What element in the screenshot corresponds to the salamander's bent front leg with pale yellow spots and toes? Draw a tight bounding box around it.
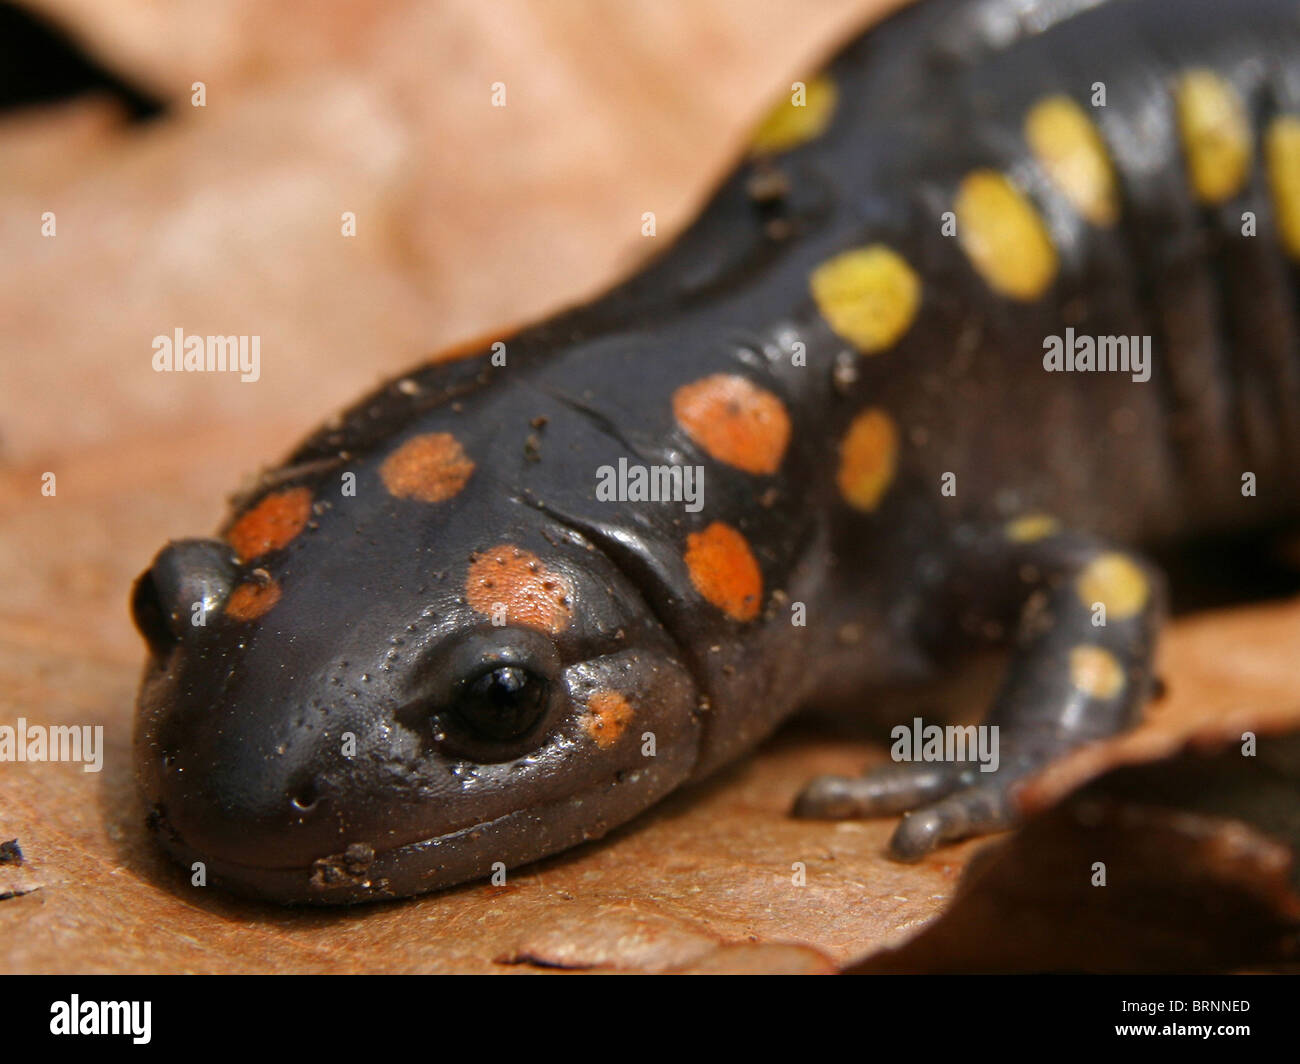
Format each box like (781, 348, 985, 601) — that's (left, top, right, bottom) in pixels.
(794, 518, 1165, 861)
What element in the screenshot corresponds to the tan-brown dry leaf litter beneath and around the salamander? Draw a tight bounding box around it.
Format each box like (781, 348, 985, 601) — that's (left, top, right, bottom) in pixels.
(0, 0, 1300, 972)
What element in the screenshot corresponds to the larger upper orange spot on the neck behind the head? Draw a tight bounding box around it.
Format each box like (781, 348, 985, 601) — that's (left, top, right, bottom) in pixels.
(672, 373, 790, 473)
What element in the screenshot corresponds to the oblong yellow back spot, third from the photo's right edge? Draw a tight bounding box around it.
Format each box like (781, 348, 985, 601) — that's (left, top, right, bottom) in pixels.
(1024, 96, 1119, 225)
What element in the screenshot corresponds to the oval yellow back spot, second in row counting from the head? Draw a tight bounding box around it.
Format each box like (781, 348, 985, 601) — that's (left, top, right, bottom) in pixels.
(953, 170, 1057, 302)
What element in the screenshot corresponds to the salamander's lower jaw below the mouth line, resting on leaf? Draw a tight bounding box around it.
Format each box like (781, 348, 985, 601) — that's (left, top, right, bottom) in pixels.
(148, 762, 681, 905)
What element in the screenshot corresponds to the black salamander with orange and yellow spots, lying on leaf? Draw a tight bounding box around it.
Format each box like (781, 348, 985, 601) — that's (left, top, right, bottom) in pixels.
(131, 0, 1300, 903)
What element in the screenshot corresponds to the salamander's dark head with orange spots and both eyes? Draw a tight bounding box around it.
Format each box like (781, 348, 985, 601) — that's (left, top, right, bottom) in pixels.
(133, 434, 699, 903)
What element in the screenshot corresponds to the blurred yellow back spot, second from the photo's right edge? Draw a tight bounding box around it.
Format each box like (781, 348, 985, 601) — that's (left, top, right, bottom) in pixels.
(1175, 70, 1253, 203)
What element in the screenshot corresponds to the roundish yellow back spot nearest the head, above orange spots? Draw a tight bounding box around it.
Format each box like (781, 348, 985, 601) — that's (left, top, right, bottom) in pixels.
(809, 243, 920, 355)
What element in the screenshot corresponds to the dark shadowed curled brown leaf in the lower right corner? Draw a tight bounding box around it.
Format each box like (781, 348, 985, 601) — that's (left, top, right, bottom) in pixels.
(855, 731, 1300, 972)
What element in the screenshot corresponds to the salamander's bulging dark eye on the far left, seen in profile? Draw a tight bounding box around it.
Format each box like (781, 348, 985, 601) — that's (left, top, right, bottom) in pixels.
(131, 540, 238, 658)
